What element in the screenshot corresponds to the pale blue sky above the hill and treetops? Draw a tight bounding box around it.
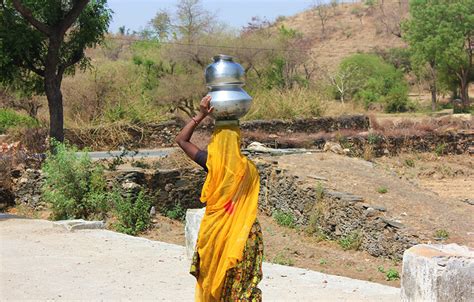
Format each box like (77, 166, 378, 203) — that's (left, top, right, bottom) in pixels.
(108, 0, 313, 32)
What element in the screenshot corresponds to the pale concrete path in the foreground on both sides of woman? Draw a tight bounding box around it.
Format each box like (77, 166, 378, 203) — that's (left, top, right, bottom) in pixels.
(0, 217, 400, 301)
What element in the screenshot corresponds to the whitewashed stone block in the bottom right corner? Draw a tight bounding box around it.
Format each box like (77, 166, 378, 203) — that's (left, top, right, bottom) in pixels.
(401, 244, 474, 302)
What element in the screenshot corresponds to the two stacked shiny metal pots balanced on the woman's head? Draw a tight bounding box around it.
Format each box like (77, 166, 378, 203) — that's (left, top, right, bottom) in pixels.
(205, 55, 252, 121)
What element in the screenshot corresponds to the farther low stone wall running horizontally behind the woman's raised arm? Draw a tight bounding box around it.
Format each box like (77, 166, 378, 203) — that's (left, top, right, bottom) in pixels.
(9, 115, 474, 156)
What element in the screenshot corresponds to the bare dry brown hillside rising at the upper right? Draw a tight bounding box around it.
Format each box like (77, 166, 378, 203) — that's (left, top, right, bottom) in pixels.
(277, 1, 407, 68)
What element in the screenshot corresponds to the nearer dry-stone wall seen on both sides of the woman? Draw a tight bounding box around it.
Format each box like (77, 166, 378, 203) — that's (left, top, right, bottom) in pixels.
(9, 160, 417, 258)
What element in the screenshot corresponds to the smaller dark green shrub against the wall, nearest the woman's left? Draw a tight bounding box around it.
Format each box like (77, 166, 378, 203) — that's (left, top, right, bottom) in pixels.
(111, 189, 151, 235)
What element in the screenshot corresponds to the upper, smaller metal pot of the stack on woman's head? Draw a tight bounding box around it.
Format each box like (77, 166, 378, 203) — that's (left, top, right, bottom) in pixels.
(206, 55, 244, 87)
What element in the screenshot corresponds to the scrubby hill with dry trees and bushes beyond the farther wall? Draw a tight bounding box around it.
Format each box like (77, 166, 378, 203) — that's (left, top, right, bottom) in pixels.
(0, 0, 474, 138)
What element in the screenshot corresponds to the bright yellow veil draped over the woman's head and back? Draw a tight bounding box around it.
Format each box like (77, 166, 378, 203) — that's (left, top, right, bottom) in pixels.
(196, 126, 260, 302)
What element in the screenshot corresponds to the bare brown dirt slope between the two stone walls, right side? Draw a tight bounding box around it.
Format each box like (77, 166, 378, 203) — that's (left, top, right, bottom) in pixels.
(272, 153, 474, 247)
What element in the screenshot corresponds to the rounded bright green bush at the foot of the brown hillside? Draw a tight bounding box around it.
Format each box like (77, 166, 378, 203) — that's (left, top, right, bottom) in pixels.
(339, 54, 410, 112)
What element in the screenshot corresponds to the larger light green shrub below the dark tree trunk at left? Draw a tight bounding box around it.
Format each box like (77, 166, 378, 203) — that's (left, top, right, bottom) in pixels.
(42, 141, 109, 220)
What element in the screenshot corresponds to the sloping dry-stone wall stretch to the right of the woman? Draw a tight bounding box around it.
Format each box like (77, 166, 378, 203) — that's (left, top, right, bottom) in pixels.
(258, 162, 417, 259)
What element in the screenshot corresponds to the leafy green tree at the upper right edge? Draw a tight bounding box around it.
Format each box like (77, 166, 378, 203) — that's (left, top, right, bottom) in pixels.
(403, 0, 474, 110)
